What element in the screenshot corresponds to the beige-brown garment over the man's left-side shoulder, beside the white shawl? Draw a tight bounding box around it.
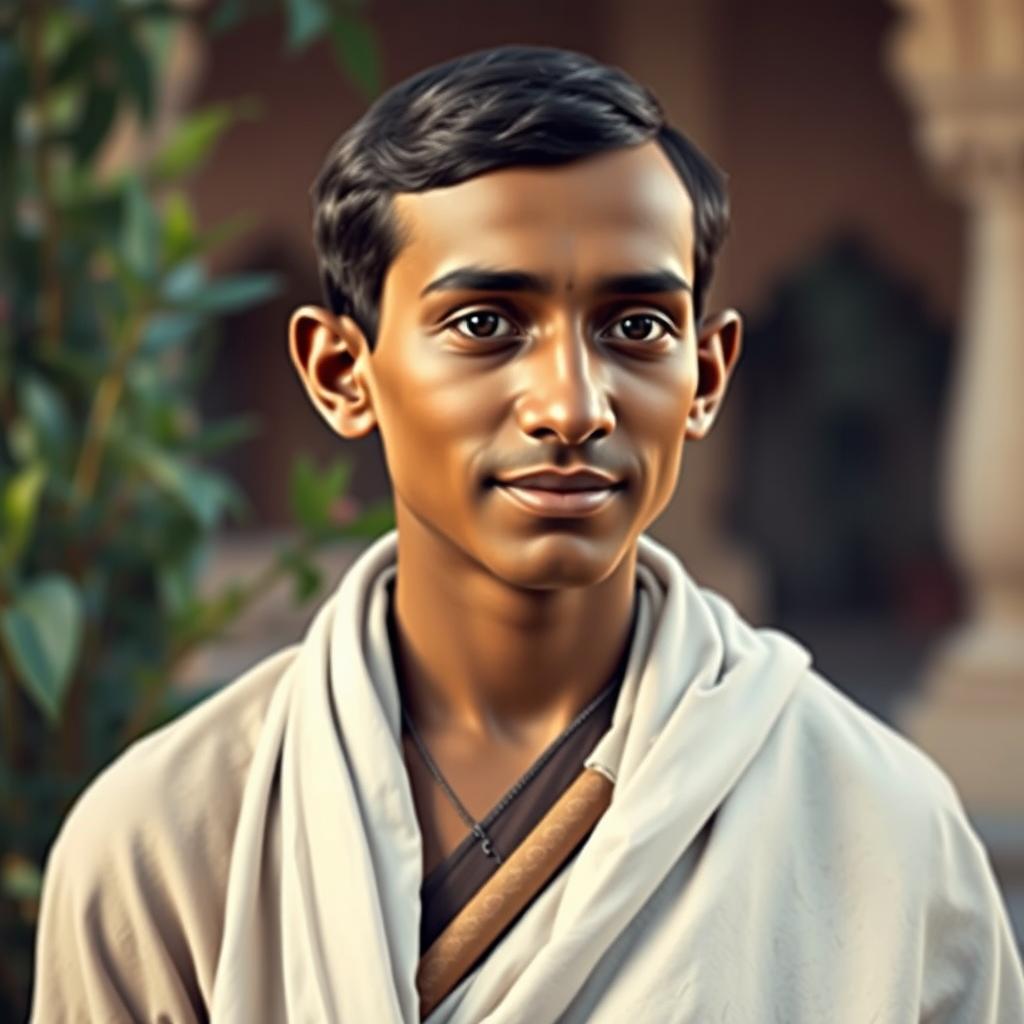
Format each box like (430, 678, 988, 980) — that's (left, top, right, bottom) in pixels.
(34, 648, 295, 1020)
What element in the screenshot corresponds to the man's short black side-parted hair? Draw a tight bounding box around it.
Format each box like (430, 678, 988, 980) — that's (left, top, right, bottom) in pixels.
(310, 46, 729, 346)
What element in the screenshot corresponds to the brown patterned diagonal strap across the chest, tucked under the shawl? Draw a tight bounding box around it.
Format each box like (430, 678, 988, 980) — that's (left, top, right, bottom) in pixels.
(416, 768, 613, 1020)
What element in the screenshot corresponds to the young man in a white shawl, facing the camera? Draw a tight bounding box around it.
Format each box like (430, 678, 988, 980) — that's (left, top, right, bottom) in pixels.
(28, 48, 1024, 1024)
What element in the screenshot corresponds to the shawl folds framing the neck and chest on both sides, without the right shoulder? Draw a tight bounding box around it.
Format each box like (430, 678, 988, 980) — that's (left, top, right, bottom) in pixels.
(213, 534, 823, 1022)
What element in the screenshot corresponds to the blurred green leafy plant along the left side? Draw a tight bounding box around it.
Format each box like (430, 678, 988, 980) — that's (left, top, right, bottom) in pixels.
(0, 0, 392, 1019)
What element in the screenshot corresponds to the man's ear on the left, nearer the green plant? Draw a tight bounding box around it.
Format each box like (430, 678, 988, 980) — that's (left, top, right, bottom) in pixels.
(288, 306, 377, 438)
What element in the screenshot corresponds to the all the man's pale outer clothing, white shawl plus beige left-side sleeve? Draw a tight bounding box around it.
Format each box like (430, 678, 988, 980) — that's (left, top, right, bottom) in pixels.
(33, 534, 1024, 1024)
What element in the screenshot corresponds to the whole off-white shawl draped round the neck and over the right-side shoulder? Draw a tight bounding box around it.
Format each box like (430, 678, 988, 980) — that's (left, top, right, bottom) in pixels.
(207, 535, 1024, 1024)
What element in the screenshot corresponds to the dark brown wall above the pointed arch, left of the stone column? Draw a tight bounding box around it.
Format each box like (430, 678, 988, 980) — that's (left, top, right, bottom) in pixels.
(717, 0, 962, 315)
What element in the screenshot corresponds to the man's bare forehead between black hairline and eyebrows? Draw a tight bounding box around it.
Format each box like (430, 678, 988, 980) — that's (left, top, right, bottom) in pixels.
(385, 142, 693, 298)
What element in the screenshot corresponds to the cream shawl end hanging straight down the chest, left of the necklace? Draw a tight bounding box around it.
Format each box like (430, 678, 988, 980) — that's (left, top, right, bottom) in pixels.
(212, 535, 422, 1024)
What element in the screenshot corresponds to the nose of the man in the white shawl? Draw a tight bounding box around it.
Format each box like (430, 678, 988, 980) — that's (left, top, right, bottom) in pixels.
(518, 328, 615, 444)
